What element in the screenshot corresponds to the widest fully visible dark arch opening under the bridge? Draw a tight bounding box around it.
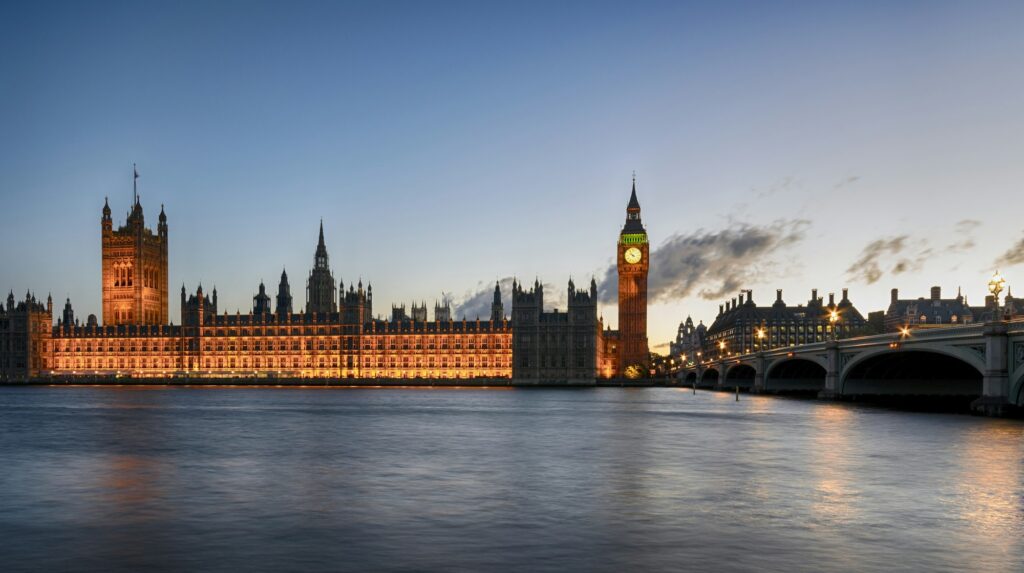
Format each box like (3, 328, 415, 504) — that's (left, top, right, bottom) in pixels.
(841, 349, 983, 398)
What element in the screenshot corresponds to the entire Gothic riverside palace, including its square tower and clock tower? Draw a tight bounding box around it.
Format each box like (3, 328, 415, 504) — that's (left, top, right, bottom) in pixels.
(0, 177, 648, 384)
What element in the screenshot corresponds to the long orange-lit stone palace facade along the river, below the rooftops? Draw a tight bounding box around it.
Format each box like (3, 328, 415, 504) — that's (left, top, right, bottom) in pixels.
(53, 287, 512, 379)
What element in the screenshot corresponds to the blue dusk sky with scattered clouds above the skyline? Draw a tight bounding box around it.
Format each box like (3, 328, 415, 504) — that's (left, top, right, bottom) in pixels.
(0, 1, 1024, 350)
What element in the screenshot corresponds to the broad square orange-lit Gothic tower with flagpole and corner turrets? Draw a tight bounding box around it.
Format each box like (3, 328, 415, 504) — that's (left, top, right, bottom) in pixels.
(100, 167, 169, 325)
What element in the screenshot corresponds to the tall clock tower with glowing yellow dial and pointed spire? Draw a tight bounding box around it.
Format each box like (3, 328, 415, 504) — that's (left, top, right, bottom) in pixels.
(615, 177, 650, 378)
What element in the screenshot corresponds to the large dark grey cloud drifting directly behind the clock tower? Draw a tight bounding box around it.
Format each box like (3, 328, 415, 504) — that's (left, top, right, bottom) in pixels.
(600, 219, 811, 304)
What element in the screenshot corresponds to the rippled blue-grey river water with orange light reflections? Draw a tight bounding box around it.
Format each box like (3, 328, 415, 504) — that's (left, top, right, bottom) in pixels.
(0, 387, 1024, 573)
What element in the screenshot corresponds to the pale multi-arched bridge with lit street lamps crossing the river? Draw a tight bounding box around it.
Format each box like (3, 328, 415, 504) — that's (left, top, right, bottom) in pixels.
(676, 319, 1024, 415)
